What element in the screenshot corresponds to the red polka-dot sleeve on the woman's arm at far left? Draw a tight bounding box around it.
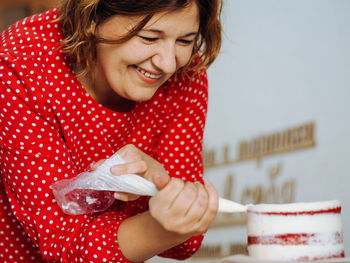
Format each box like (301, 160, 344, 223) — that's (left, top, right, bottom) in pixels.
(0, 55, 129, 262)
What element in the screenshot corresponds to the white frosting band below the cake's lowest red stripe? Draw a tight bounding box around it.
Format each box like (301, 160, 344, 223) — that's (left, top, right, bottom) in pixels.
(248, 244, 344, 260)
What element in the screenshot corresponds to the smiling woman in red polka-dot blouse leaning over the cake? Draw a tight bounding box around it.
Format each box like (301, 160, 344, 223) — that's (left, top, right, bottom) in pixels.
(0, 0, 221, 262)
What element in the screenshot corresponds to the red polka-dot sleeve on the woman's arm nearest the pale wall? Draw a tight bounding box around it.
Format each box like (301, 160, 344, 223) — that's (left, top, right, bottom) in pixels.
(156, 70, 208, 259)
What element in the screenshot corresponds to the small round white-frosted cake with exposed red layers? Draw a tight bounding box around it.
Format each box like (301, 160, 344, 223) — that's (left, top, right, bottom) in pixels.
(247, 200, 344, 261)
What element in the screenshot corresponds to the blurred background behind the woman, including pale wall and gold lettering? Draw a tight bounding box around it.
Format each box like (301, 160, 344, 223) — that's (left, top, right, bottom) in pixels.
(0, 0, 350, 262)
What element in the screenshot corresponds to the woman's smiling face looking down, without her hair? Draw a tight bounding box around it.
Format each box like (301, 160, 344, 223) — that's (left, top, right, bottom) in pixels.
(93, 3, 199, 101)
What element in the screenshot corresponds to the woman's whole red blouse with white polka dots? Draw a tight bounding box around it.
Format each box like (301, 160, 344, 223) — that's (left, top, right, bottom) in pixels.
(0, 9, 208, 262)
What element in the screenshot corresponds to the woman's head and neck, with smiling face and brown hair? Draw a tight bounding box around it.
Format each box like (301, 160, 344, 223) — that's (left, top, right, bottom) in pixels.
(61, 1, 221, 111)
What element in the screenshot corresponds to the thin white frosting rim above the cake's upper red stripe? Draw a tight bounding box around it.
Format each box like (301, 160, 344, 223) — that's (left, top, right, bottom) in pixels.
(248, 200, 340, 213)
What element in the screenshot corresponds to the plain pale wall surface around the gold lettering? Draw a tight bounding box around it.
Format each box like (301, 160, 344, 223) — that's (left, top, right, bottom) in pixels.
(148, 0, 350, 262)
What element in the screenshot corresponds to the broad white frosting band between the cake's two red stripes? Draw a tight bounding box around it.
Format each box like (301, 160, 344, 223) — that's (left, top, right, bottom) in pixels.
(247, 213, 342, 236)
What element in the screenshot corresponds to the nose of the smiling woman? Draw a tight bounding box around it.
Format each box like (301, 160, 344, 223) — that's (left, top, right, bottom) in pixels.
(152, 42, 177, 74)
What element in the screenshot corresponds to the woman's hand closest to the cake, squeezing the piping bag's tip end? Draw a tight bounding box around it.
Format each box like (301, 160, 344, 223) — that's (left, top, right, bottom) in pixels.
(149, 178, 218, 237)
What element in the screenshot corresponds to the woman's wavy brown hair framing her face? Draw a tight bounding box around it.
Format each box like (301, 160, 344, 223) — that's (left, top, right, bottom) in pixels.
(58, 0, 222, 76)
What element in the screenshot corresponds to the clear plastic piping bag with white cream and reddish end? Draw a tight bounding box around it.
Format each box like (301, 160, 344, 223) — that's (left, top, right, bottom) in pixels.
(52, 154, 247, 215)
